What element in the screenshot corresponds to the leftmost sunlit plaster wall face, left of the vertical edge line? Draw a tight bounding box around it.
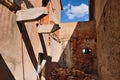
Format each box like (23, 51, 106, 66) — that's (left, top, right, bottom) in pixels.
(0, 4, 23, 80)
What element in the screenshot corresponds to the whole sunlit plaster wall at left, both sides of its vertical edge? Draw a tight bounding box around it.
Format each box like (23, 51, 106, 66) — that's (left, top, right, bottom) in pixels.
(0, 0, 43, 80)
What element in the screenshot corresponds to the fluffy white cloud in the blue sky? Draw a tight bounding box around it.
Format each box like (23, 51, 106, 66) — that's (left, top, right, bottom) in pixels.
(63, 3, 88, 19)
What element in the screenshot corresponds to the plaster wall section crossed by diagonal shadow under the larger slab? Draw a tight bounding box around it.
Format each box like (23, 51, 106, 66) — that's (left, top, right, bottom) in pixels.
(16, 0, 43, 80)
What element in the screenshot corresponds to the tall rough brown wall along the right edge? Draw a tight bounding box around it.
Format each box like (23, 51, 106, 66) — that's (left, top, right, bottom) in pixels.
(96, 0, 120, 80)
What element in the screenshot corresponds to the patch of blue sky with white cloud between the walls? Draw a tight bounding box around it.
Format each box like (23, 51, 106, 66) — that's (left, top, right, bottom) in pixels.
(61, 0, 89, 22)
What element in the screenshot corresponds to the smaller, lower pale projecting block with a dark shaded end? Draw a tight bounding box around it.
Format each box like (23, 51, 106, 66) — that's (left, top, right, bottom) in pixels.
(38, 24, 60, 33)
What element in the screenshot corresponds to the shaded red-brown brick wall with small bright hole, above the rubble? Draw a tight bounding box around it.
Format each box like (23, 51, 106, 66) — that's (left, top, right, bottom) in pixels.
(71, 21, 97, 74)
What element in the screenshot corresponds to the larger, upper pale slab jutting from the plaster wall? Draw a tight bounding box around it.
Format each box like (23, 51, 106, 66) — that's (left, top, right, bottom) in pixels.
(16, 7, 48, 21)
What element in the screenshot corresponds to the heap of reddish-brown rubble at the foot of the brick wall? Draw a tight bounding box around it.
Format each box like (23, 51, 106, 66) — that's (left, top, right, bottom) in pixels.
(49, 68, 98, 80)
